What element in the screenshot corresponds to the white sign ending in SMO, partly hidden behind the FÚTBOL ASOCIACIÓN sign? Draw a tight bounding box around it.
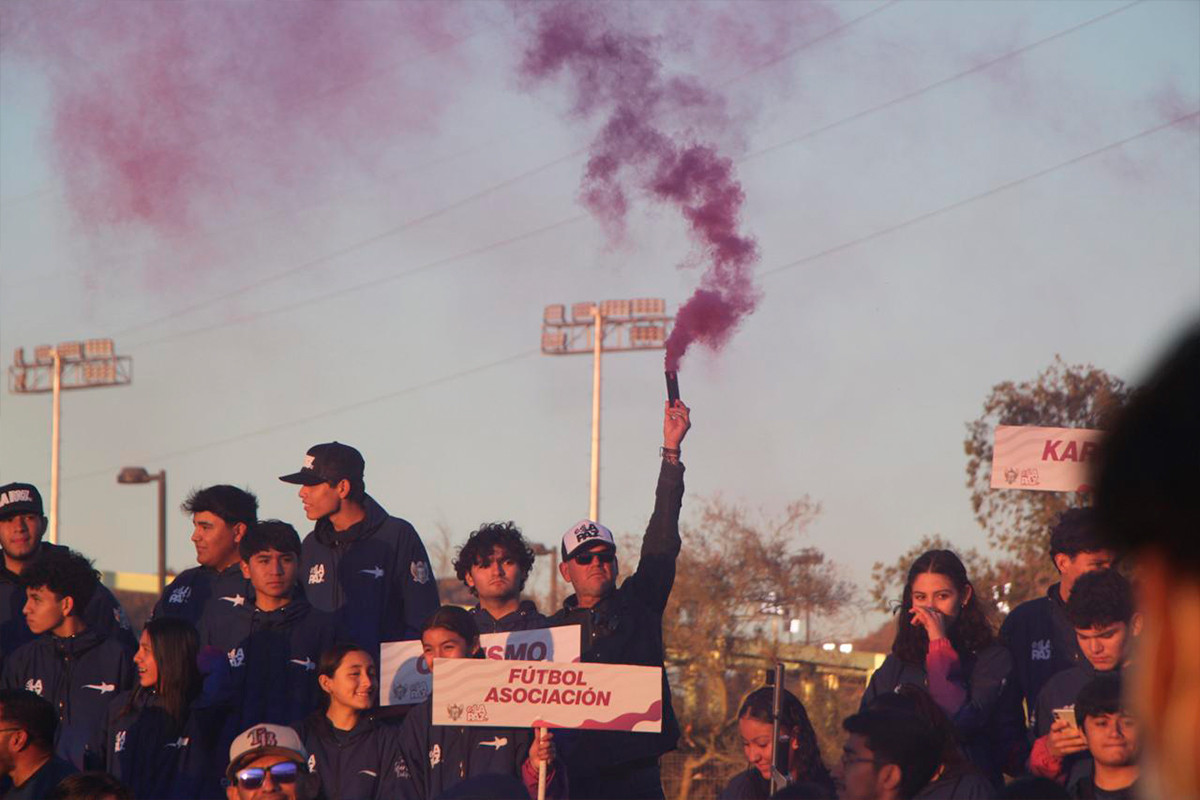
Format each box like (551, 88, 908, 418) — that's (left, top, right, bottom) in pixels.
(379, 625, 582, 705)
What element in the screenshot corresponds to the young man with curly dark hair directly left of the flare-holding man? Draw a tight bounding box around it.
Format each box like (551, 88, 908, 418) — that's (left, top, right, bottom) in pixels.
(454, 522, 546, 633)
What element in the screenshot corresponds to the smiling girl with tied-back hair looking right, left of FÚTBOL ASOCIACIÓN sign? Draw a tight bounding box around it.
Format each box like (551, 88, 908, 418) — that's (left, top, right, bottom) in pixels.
(294, 644, 408, 800)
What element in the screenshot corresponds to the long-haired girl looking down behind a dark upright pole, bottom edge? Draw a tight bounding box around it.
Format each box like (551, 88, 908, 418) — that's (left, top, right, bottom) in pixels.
(718, 686, 834, 800)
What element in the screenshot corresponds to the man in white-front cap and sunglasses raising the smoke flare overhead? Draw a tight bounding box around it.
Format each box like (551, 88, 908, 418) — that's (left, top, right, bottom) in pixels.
(548, 401, 691, 800)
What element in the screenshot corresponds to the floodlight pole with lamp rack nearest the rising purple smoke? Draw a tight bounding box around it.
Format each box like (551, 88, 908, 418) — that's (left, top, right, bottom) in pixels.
(541, 297, 674, 522)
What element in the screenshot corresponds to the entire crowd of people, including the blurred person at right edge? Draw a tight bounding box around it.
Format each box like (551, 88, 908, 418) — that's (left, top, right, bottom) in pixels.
(0, 323, 1200, 800)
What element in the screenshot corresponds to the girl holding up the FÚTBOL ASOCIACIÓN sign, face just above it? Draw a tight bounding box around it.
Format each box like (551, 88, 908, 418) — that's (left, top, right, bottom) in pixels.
(401, 606, 566, 800)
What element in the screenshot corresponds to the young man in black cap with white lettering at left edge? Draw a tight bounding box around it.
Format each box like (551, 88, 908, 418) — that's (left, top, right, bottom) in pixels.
(0, 483, 137, 662)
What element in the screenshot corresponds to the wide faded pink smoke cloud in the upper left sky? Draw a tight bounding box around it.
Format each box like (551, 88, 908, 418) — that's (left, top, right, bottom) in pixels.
(0, 0, 463, 234)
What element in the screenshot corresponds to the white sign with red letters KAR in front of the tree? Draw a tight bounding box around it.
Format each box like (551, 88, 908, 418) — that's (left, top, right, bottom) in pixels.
(991, 425, 1104, 492)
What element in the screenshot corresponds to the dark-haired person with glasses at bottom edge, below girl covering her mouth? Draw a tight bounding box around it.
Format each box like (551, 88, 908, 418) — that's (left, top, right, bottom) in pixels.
(833, 710, 941, 800)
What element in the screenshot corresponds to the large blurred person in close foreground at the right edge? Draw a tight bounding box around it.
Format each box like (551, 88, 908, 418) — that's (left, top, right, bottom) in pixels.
(1093, 324, 1200, 800)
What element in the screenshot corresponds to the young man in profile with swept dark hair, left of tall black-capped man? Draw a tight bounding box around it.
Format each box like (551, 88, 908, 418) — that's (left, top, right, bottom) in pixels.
(152, 485, 258, 628)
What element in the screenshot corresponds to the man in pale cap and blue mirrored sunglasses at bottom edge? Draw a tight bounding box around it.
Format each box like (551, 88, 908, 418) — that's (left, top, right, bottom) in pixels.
(226, 724, 319, 800)
